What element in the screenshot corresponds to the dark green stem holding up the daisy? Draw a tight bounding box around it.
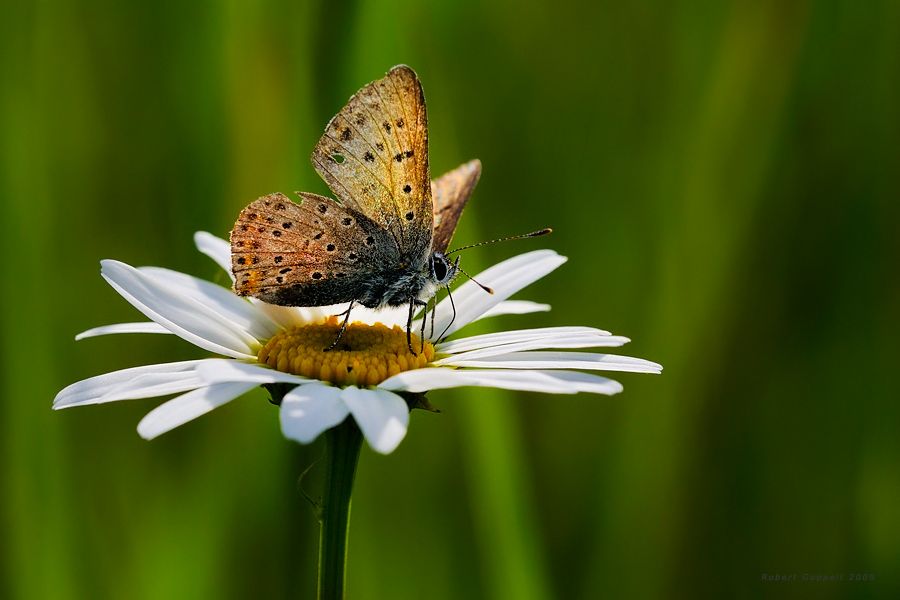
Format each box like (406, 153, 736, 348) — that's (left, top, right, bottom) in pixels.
(319, 417, 363, 600)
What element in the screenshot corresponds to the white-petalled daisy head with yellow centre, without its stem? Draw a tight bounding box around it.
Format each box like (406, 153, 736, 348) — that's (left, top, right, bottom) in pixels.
(53, 232, 662, 454)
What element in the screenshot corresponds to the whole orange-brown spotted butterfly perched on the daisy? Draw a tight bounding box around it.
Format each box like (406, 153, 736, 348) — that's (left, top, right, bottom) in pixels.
(231, 65, 481, 353)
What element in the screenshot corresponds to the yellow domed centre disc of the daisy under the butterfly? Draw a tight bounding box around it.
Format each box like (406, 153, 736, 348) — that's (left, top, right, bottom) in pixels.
(258, 317, 434, 386)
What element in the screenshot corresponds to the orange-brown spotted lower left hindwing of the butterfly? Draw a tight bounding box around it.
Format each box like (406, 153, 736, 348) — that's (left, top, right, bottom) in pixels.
(231, 193, 396, 306)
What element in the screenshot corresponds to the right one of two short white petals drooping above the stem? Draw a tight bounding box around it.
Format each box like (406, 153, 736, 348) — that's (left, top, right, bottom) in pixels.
(341, 387, 409, 454)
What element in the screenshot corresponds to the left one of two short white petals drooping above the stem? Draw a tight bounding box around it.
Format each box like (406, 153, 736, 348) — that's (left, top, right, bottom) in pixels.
(281, 383, 350, 444)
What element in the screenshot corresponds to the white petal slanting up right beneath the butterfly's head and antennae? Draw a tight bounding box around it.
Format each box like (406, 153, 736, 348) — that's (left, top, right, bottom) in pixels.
(419, 250, 567, 336)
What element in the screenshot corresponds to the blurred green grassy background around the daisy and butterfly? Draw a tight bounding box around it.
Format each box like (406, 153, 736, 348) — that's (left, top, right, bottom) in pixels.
(0, 0, 900, 600)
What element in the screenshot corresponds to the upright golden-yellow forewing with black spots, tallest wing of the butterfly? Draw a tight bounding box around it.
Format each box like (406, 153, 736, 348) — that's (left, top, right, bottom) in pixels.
(312, 66, 433, 256)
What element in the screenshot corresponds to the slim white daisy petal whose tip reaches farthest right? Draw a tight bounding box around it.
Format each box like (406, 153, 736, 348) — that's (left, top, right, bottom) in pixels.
(440, 352, 662, 373)
